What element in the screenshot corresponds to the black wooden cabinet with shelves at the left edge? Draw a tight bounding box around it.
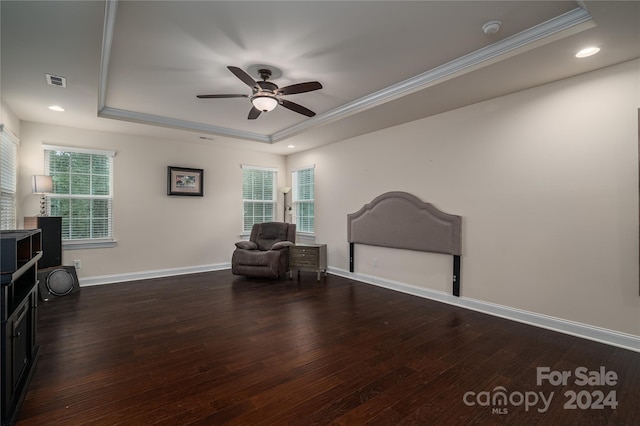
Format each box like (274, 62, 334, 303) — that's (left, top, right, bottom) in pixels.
(0, 229, 42, 425)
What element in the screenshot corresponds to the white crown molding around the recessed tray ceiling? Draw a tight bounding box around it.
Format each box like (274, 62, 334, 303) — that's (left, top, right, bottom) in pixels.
(98, 0, 595, 144)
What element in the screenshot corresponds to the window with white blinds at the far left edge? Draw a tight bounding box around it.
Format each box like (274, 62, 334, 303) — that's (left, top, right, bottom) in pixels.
(0, 125, 18, 229)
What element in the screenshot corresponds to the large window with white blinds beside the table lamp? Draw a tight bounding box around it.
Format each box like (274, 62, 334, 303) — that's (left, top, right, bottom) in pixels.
(44, 146, 115, 243)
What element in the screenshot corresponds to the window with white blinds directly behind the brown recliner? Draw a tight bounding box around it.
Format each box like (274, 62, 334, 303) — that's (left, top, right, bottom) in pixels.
(242, 165, 276, 233)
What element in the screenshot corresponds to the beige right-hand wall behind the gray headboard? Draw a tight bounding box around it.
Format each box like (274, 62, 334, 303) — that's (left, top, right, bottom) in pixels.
(287, 61, 640, 336)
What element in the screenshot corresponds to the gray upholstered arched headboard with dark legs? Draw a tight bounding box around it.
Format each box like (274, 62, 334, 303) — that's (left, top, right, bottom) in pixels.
(347, 191, 462, 296)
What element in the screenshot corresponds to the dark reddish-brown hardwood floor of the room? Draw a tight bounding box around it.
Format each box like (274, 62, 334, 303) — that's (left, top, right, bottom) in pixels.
(18, 271, 640, 426)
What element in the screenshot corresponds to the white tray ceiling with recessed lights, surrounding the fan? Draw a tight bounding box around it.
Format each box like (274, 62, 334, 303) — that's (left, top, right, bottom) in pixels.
(0, 0, 640, 155)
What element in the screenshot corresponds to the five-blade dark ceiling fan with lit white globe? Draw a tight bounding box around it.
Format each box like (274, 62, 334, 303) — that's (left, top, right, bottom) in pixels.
(196, 66, 322, 120)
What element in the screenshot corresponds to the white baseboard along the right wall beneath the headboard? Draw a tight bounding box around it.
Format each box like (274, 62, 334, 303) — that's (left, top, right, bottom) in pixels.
(328, 268, 640, 352)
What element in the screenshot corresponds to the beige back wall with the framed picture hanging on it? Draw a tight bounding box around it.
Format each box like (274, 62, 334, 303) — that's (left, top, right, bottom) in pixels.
(18, 122, 286, 281)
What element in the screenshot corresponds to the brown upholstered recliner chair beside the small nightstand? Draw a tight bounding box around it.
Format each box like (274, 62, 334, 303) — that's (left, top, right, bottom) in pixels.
(231, 222, 296, 278)
